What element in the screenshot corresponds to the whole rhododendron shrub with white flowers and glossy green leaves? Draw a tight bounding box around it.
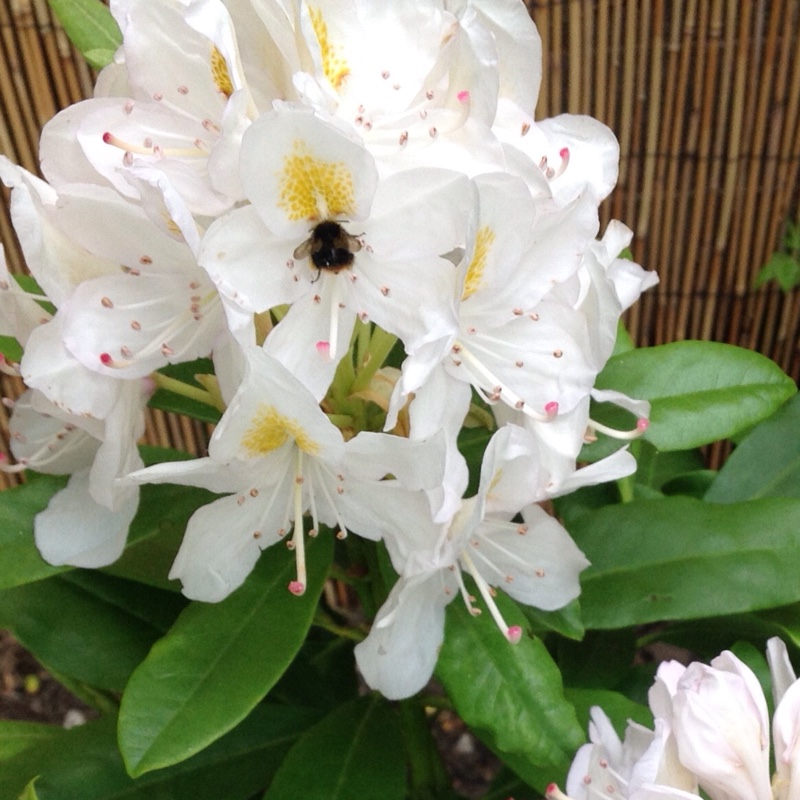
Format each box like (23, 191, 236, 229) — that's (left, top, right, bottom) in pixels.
(0, 0, 800, 800)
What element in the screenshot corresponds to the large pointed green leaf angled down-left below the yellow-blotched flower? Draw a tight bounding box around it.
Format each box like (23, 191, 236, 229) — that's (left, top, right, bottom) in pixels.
(119, 532, 333, 776)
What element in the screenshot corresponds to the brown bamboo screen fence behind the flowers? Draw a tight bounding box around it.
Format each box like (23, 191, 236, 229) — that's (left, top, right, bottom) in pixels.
(0, 0, 800, 485)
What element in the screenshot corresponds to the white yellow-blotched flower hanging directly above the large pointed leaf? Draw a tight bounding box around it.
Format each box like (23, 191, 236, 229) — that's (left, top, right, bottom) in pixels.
(131, 348, 441, 602)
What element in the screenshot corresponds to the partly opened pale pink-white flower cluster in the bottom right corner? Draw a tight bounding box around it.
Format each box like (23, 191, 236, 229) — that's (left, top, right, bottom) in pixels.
(546, 638, 800, 800)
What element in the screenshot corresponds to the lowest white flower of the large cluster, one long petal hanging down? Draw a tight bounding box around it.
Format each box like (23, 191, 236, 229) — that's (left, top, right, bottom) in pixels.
(355, 426, 589, 699)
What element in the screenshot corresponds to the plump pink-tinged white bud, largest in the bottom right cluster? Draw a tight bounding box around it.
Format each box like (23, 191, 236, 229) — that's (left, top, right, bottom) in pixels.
(672, 651, 772, 800)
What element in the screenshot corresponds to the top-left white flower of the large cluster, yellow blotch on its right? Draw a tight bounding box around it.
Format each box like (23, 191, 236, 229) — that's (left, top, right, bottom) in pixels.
(41, 0, 257, 216)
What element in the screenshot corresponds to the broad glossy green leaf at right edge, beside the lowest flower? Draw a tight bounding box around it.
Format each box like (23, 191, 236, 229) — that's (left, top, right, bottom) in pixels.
(570, 497, 800, 628)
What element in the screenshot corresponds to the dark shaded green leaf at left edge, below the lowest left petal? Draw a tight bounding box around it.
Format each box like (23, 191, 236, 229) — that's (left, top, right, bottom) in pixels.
(0, 575, 182, 691)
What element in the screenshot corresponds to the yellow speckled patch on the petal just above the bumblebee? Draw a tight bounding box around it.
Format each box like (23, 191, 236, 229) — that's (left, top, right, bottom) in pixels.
(278, 140, 356, 222)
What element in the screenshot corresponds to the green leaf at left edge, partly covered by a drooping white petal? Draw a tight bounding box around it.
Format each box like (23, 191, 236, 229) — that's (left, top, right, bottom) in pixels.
(0, 475, 70, 589)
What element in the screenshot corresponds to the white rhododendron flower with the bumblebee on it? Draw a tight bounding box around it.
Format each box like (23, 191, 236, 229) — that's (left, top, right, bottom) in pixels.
(200, 107, 471, 396)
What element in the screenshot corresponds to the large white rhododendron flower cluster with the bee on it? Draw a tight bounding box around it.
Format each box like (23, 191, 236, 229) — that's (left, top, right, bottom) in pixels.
(0, 0, 656, 697)
